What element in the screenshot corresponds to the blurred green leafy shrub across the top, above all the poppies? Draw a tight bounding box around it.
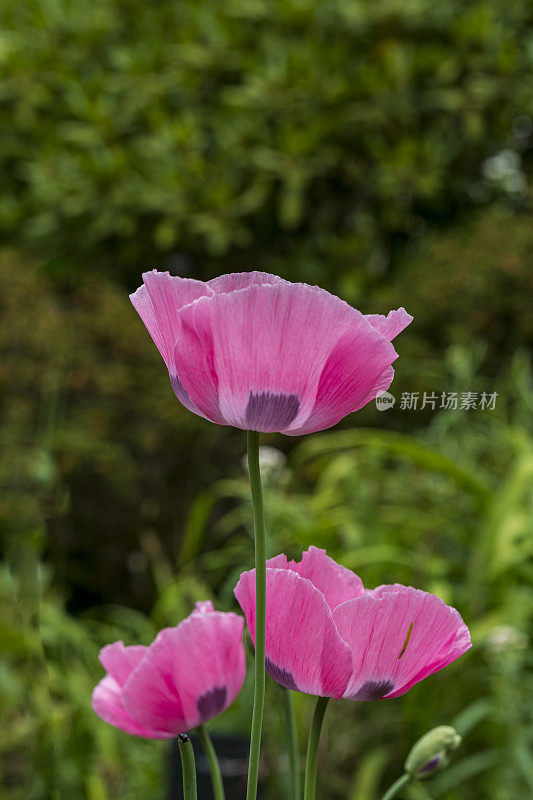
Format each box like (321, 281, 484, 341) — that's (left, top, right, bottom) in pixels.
(0, 0, 533, 278)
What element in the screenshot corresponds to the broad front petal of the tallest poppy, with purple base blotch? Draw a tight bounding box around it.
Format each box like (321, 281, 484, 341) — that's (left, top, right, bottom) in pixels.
(175, 282, 382, 433)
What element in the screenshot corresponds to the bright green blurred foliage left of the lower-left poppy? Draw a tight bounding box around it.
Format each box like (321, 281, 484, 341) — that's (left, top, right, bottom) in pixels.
(0, 568, 162, 800)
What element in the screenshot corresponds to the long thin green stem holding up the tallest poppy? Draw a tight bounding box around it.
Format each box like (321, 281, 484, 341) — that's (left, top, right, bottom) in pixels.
(246, 431, 266, 800)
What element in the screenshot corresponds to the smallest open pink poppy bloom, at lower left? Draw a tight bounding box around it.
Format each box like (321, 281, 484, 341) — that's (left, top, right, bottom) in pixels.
(92, 601, 245, 739)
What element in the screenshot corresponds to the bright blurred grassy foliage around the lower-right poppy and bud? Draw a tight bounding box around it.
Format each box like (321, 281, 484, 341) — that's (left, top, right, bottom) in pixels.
(195, 353, 533, 800)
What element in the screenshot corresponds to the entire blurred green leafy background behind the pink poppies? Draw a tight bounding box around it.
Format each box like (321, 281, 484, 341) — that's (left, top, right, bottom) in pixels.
(0, 0, 533, 800)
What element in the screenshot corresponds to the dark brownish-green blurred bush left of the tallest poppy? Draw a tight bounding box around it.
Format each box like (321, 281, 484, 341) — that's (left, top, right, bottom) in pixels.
(0, 254, 244, 608)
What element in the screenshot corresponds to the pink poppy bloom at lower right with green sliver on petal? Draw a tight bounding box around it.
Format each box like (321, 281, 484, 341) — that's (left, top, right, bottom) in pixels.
(235, 547, 471, 700)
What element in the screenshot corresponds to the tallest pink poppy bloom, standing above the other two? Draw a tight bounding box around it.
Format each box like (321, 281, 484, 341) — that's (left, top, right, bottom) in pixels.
(131, 270, 412, 436)
